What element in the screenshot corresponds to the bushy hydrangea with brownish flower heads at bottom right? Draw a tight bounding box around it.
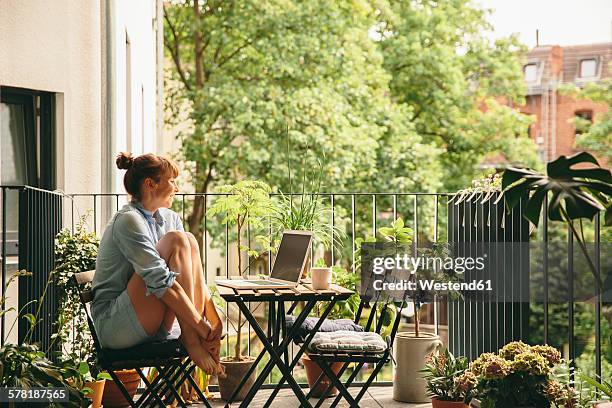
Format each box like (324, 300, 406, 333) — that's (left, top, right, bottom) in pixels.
(465, 341, 576, 408)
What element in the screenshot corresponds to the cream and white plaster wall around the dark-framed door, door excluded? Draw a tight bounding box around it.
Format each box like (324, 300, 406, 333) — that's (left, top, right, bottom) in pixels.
(0, 0, 158, 341)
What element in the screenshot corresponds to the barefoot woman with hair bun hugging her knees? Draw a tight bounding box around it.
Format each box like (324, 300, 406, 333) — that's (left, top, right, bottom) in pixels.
(91, 153, 222, 374)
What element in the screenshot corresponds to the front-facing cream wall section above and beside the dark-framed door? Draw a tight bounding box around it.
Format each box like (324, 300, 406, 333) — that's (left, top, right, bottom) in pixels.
(0, 0, 102, 191)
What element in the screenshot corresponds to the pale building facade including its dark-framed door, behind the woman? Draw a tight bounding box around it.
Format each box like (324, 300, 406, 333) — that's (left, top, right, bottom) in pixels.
(0, 0, 163, 341)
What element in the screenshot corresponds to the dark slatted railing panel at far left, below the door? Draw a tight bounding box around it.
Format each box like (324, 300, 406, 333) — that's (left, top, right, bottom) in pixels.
(0, 186, 63, 351)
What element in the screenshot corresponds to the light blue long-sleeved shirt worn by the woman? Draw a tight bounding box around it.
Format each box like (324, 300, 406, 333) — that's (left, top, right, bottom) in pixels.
(91, 201, 184, 320)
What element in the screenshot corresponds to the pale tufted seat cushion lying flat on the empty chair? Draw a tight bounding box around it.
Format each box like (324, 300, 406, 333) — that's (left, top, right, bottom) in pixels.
(308, 330, 387, 353)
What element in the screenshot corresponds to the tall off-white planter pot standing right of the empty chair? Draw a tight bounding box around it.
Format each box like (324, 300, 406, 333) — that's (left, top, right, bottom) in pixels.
(393, 333, 442, 402)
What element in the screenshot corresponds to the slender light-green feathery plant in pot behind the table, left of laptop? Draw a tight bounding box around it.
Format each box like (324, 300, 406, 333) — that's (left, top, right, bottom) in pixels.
(208, 180, 275, 400)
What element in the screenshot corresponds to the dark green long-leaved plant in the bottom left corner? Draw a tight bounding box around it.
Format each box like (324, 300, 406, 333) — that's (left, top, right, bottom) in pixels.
(0, 270, 89, 408)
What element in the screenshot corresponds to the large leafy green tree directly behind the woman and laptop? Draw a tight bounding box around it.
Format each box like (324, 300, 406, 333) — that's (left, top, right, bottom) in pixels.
(165, 0, 440, 242)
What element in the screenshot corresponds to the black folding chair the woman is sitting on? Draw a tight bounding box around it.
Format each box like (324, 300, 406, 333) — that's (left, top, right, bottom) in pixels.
(73, 271, 210, 408)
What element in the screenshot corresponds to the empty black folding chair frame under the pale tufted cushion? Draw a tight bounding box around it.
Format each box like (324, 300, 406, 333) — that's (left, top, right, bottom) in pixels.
(306, 299, 404, 408)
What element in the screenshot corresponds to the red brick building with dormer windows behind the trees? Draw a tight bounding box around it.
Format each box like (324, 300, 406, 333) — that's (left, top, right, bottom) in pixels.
(521, 42, 612, 161)
